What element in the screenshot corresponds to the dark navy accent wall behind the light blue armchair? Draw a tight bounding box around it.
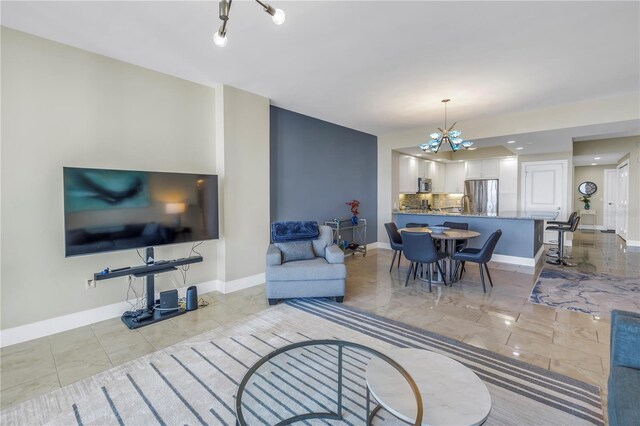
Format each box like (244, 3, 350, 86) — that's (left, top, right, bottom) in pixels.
(270, 106, 378, 243)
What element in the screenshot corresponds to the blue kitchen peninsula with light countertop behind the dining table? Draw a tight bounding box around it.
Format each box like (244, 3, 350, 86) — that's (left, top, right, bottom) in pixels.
(393, 210, 556, 267)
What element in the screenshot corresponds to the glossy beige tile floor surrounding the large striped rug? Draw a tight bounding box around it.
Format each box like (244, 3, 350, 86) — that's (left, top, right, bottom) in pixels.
(0, 232, 640, 408)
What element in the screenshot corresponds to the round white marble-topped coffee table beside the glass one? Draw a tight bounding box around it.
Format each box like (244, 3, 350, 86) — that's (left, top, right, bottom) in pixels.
(366, 348, 491, 426)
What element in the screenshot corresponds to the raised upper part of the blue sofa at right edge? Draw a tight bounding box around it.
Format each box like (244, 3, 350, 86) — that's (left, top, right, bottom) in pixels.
(611, 310, 640, 369)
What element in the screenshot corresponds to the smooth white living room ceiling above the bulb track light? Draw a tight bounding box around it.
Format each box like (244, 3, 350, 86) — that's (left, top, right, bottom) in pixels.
(1, 0, 640, 134)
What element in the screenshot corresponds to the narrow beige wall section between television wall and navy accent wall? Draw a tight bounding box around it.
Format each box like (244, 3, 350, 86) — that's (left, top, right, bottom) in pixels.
(219, 86, 270, 282)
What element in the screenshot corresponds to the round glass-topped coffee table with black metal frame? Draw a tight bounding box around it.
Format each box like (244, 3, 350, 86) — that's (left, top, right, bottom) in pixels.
(235, 340, 424, 426)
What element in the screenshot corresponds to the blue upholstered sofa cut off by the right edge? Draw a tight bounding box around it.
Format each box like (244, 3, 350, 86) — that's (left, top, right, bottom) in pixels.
(607, 310, 640, 426)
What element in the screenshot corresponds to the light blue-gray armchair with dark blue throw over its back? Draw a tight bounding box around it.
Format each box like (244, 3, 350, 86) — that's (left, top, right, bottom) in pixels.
(266, 226, 347, 305)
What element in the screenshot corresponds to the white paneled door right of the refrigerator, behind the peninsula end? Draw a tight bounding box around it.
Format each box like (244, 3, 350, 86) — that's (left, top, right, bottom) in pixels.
(521, 161, 568, 243)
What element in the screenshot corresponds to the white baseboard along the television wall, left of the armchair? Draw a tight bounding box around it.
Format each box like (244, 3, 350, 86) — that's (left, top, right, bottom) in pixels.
(0, 274, 255, 347)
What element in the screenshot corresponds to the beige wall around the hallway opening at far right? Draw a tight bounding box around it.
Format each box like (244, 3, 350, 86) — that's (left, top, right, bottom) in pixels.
(573, 136, 640, 246)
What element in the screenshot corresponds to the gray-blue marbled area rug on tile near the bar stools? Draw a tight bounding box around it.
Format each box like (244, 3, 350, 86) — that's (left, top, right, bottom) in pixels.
(529, 266, 640, 317)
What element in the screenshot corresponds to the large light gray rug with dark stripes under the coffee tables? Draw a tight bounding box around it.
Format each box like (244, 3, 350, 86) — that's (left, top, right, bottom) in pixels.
(0, 299, 604, 425)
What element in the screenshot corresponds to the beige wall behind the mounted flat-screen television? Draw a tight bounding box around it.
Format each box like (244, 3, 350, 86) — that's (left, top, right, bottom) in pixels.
(0, 28, 218, 329)
